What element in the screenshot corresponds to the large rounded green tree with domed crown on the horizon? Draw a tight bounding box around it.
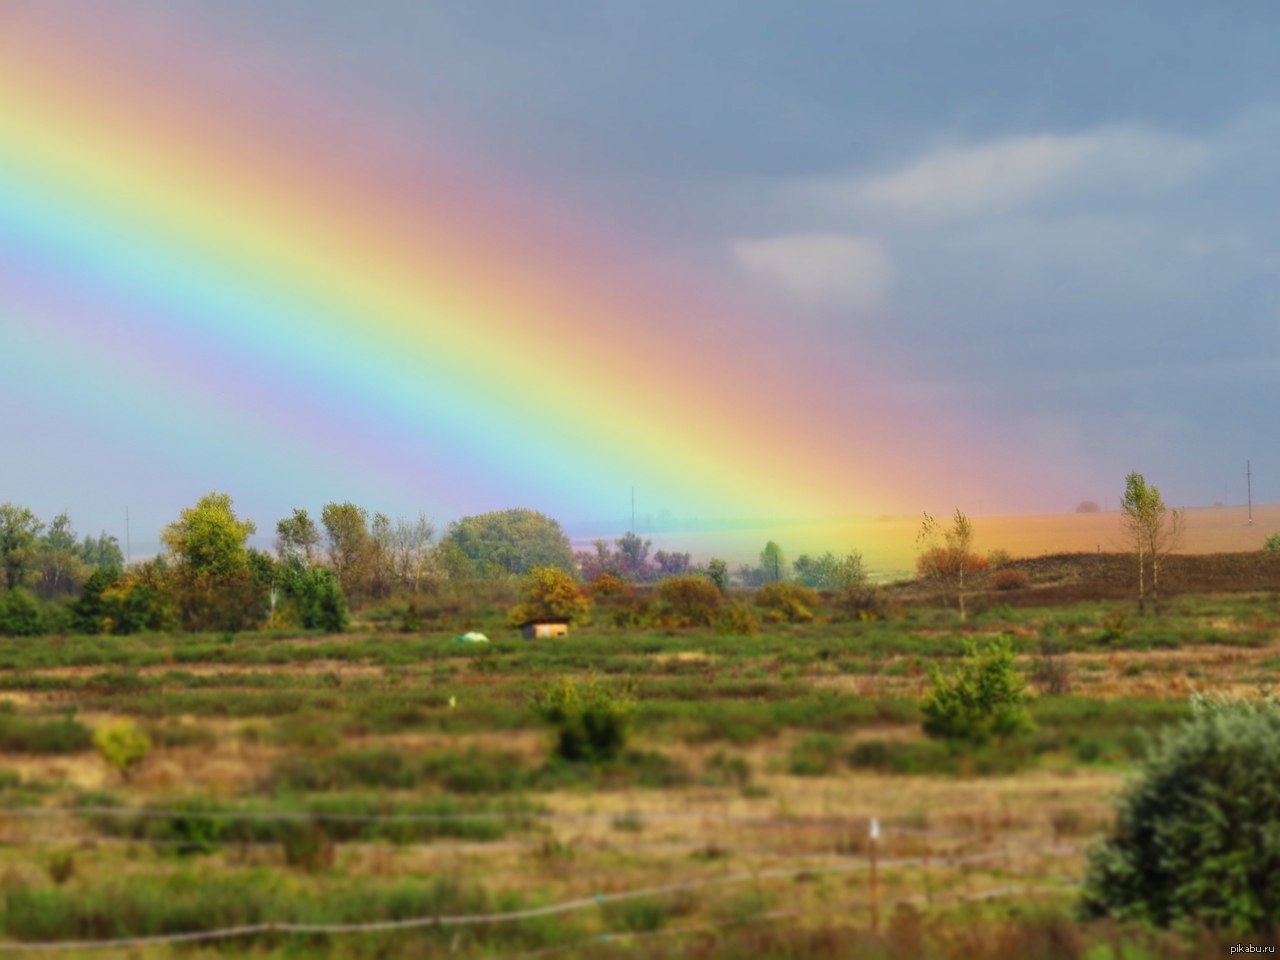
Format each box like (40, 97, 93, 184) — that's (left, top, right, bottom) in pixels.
(444, 507, 575, 579)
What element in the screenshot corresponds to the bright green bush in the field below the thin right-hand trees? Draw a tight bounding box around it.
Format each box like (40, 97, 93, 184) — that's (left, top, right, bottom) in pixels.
(920, 637, 1032, 744)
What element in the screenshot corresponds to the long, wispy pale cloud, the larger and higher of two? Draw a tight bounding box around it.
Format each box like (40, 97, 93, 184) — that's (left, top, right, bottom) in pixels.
(796, 127, 1208, 220)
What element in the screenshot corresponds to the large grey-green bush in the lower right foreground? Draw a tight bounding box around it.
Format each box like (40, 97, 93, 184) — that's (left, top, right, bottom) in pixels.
(1082, 696, 1280, 934)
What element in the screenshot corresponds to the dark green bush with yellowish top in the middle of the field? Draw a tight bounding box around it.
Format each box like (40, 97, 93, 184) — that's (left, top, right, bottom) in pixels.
(534, 677, 635, 763)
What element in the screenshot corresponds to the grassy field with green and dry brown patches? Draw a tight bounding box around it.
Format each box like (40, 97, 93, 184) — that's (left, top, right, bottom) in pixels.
(0, 553, 1280, 957)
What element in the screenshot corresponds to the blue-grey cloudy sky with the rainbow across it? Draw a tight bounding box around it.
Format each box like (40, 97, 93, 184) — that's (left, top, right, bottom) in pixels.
(0, 0, 1280, 555)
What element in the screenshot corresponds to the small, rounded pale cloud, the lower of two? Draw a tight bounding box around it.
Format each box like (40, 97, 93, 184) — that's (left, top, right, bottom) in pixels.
(732, 233, 893, 310)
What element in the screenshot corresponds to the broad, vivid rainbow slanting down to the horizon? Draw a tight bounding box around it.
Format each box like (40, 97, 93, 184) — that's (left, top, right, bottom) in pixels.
(0, 8, 1080, 563)
